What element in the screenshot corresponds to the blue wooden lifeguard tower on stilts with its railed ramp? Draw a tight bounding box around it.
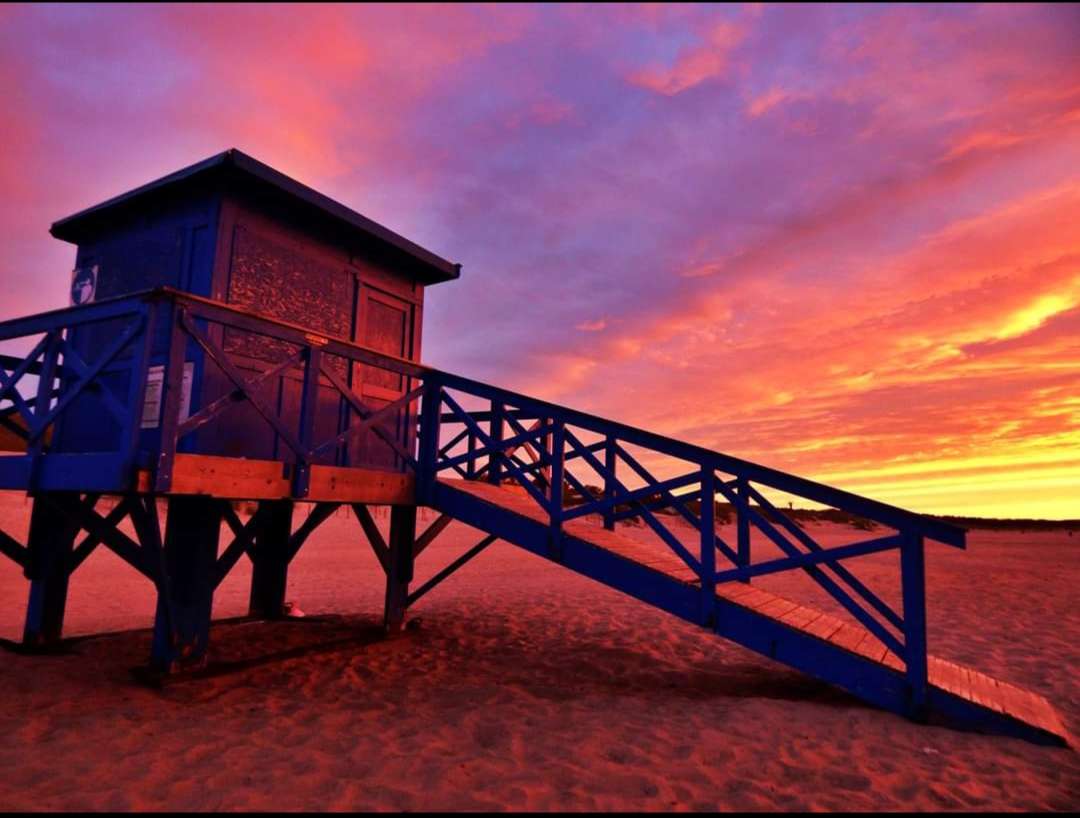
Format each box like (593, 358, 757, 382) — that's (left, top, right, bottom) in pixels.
(0, 150, 1068, 743)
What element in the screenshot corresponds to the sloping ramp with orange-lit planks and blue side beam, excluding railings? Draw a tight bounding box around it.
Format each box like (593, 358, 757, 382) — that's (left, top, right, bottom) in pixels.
(433, 479, 1069, 745)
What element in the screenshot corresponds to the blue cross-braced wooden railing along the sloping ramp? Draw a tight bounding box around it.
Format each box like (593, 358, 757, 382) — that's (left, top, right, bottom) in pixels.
(419, 372, 964, 706)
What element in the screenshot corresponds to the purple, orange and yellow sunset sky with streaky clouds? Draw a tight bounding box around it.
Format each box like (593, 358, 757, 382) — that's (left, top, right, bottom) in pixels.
(0, 4, 1080, 518)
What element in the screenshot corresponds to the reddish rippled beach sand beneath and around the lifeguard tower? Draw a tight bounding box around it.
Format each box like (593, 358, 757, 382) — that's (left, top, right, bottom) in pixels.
(0, 495, 1080, 810)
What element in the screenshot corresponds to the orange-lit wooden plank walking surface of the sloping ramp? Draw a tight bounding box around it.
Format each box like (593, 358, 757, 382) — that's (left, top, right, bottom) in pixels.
(440, 480, 1071, 745)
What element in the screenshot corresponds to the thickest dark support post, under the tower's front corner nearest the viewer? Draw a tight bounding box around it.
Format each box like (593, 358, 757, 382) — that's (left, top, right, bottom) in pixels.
(151, 495, 221, 673)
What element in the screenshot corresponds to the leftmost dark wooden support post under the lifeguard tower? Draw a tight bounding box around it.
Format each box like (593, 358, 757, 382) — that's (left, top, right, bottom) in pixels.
(23, 492, 79, 647)
